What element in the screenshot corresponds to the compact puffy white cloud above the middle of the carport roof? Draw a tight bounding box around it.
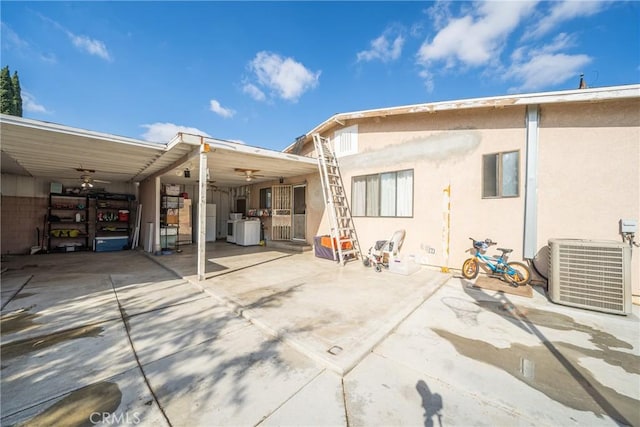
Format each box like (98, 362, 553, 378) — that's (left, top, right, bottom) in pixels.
(249, 51, 320, 102)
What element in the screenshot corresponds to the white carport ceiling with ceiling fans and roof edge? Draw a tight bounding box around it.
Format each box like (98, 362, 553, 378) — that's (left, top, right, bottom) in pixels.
(0, 114, 317, 187)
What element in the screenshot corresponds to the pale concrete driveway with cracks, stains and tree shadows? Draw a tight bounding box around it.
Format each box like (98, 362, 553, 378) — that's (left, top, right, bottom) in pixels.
(0, 244, 640, 426)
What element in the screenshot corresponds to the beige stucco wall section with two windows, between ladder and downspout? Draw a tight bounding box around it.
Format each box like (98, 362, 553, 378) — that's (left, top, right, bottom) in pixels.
(332, 108, 525, 267)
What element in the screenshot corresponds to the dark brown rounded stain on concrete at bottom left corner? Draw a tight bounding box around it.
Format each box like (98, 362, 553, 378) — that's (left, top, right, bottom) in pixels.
(18, 381, 122, 426)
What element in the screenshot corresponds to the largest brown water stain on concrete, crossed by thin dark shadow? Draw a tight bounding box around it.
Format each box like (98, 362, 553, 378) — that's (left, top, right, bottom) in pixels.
(434, 329, 640, 425)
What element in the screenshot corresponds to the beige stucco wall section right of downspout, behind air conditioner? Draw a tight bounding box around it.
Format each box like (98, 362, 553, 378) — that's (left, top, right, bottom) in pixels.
(538, 101, 640, 297)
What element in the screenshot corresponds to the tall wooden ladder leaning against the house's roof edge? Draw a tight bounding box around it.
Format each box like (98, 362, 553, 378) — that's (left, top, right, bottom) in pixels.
(313, 134, 362, 265)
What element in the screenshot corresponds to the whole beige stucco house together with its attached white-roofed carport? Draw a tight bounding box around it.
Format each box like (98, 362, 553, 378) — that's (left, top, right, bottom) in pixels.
(0, 85, 640, 303)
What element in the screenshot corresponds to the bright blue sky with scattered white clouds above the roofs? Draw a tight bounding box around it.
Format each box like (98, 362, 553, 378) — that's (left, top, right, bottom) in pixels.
(0, 1, 640, 150)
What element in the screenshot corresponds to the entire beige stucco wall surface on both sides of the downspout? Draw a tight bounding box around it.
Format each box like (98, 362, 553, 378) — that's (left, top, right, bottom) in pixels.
(306, 100, 640, 303)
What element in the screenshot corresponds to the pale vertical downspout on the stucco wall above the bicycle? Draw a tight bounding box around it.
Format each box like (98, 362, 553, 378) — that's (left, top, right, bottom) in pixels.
(522, 105, 540, 259)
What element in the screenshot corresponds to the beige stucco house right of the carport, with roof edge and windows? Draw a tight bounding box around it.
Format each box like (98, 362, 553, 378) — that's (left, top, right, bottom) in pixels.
(285, 85, 640, 303)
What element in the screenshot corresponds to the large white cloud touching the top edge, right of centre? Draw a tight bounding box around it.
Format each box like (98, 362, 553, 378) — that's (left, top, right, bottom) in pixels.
(417, 1, 536, 67)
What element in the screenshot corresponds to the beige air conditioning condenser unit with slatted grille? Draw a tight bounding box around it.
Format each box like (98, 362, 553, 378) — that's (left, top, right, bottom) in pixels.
(549, 239, 631, 315)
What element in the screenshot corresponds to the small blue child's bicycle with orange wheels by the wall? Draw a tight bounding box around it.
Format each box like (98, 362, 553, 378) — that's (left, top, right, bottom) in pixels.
(462, 237, 531, 286)
